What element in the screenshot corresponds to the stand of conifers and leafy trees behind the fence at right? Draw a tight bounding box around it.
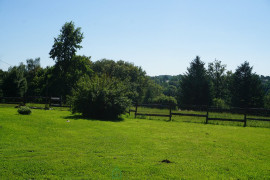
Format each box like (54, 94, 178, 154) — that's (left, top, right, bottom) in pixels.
(152, 56, 270, 108)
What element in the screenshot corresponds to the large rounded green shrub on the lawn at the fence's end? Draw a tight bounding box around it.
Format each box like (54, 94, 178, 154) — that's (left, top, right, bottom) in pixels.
(70, 75, 131, 119)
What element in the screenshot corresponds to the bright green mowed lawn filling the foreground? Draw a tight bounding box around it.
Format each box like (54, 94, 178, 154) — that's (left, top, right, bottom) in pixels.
(0, 107, 270, 179)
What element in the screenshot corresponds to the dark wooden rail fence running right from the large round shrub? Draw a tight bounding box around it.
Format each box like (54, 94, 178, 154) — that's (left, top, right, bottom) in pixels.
(129, 104, 270, 127)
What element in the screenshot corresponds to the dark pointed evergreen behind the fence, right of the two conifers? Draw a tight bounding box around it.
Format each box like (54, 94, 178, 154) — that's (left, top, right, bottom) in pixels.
(230, 61, 264, 107)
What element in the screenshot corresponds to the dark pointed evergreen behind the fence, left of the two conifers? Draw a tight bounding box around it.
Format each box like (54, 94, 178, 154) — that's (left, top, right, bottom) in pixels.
(179, 56, 211, 105)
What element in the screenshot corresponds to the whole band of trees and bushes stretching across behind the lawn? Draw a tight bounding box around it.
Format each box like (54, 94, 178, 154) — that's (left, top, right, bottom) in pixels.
(0, 22, 270, 115)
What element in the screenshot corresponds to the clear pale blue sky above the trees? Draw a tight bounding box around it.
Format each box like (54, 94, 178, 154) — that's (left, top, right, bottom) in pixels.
(0, 0, 270, 75)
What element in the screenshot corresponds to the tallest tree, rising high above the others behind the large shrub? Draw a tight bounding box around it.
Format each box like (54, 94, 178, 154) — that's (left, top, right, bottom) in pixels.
(49, 21, 83, 98)
